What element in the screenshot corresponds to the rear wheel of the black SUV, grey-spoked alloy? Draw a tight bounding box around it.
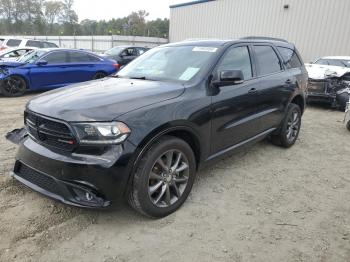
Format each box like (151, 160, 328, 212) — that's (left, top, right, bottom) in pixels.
(271, 103, 301, 148)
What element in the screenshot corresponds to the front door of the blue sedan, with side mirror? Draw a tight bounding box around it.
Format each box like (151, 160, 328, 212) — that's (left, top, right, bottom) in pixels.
(30, 51, 70, 89)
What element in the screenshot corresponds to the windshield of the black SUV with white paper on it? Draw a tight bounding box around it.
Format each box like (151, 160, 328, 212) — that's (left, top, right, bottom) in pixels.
(117, 46, 217, 82)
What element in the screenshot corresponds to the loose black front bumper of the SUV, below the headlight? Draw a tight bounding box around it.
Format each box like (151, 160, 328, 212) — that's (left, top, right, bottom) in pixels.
(11, 136, 135, 208)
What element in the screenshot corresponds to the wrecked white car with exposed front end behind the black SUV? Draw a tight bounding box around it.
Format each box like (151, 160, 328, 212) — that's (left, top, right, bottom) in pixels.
(305, 56, 350, 110)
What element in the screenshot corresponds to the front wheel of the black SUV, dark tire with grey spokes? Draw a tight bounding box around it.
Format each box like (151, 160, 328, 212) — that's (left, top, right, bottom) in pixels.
(128, 136, 196, 218)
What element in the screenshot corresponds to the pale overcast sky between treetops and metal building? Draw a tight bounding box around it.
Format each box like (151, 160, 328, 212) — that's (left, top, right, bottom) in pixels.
(73, 0, 186, 21)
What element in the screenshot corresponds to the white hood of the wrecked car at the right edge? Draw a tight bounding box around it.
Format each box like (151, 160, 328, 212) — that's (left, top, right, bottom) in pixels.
(305, 64, 350, 79)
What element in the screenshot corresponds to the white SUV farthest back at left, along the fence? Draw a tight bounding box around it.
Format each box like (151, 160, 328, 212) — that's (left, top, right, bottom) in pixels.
(0, 38, 58, 50)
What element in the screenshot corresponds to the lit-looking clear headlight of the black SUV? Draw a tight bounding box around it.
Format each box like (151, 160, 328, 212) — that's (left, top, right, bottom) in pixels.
(72, 122, 131, 145)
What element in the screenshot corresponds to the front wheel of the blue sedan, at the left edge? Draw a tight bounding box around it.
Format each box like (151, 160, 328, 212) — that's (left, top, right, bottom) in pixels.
(0, 76, 27, 97)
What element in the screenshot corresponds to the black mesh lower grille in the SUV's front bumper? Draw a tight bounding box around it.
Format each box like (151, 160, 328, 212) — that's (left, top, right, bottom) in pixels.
(16, 162, 60, 195)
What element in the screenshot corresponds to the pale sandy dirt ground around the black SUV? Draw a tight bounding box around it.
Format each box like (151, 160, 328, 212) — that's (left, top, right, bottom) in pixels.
(0, 95, 350, 262)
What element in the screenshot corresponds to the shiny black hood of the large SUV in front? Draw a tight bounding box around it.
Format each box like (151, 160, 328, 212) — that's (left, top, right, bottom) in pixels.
(27, 77, 184, 122)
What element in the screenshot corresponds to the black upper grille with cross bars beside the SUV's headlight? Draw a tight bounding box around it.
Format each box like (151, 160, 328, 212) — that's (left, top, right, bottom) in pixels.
(24, 112, 76, 151)
